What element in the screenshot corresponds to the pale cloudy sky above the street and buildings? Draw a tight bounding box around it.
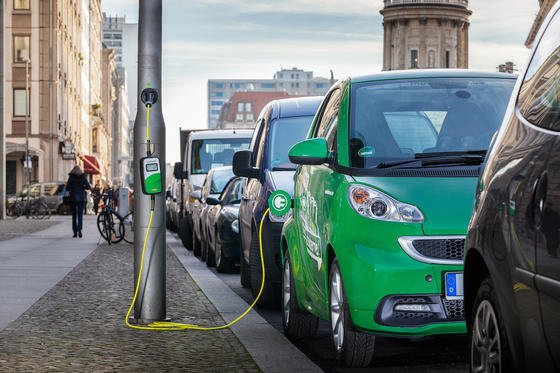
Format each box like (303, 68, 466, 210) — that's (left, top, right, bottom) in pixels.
(102, 0, 538, 163)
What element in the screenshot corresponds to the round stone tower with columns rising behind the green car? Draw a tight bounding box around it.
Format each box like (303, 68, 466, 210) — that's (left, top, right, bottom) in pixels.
(380, 0, 472, 70)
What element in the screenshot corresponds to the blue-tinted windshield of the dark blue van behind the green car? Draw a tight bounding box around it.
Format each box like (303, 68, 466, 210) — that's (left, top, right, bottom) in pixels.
(268, 116, 313, 171)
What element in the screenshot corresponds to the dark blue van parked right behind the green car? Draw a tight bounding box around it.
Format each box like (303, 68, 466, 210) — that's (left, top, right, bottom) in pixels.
(233, 97, 322, 306)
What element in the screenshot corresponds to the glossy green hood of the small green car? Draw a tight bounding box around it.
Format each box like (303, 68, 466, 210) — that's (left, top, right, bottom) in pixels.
(354, 177, 478, 235)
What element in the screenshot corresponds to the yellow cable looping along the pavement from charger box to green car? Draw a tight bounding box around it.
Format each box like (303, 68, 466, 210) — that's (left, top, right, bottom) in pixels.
(125, 208, 270, 331)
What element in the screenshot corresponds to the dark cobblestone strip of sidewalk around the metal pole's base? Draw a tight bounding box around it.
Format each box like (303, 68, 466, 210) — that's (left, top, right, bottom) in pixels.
(0, 240, 259, 372)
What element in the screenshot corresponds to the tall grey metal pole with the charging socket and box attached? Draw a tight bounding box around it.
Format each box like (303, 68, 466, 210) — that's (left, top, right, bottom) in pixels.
(132, 0, 166, 324)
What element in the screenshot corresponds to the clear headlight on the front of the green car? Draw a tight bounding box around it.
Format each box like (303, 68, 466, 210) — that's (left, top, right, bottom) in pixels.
(348, 185, 424, 223)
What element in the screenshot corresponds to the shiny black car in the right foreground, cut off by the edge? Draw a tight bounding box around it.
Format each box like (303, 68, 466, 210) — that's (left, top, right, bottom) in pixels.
(464, 4, 560, 372)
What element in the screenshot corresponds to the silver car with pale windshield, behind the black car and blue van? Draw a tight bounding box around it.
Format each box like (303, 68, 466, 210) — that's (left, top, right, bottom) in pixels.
(191, 166, 233, 258)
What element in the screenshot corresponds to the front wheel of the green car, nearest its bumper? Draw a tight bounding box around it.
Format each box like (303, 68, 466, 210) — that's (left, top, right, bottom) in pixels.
(329, 258, 375, 367)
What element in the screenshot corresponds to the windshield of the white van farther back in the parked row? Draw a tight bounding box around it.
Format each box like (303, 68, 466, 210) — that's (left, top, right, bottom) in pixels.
(191, 138, 251, 174)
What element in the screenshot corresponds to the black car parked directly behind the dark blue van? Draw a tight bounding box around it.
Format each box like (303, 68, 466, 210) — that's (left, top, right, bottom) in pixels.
(206, 177, 245, 273)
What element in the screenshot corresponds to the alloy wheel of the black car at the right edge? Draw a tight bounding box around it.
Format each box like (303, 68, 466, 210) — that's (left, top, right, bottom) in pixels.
(471, 299, 502, 372)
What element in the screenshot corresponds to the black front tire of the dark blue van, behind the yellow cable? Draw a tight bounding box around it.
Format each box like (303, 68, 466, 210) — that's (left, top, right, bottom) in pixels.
(249, 230, 278, 308)
